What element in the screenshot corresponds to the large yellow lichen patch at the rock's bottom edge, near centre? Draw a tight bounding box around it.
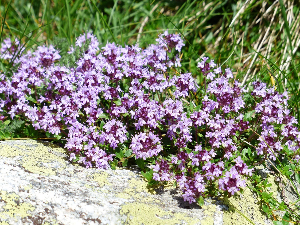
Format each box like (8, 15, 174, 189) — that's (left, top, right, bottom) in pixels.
(120, 202, 199, 225)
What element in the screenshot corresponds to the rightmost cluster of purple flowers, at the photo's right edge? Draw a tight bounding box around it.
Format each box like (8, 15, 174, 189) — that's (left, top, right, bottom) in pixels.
(252, 82, 300, 162)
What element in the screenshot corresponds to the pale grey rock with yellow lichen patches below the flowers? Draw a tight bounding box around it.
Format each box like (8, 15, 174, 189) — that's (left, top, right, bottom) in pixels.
(0, 140, 296, 225)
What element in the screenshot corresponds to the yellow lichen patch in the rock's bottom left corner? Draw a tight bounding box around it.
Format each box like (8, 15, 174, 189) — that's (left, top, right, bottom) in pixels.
(0, 191, 35, 220)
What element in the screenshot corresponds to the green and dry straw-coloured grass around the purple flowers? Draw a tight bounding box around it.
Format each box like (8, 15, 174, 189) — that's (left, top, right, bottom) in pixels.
(0, 0, 300, 224)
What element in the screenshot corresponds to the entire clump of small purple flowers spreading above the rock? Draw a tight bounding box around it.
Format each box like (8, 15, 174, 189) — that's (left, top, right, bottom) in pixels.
(0, 32, 300, 203)
